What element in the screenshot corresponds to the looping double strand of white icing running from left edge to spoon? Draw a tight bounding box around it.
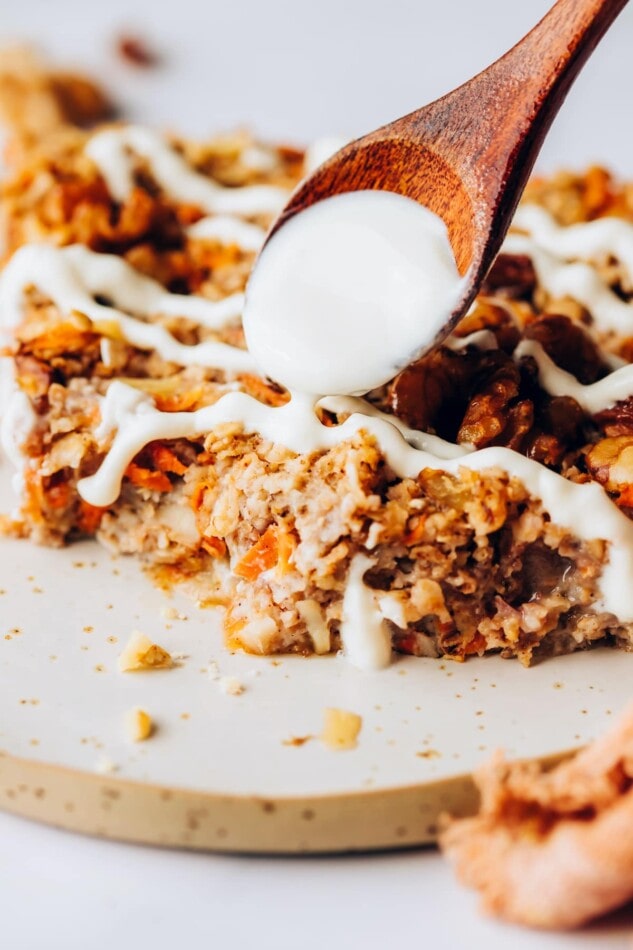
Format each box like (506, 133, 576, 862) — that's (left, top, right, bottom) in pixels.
(0, 244, 254, 372)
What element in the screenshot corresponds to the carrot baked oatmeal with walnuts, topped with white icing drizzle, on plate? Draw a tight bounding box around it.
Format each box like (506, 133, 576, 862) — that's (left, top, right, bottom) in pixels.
(0, 55, 633, 666)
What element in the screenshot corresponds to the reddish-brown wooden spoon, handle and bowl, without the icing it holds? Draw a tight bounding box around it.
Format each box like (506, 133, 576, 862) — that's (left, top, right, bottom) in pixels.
(269, 0, 627, 345)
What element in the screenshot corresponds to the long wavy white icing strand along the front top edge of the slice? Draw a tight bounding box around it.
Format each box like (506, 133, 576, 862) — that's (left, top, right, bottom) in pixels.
(78, 382, 633, 622)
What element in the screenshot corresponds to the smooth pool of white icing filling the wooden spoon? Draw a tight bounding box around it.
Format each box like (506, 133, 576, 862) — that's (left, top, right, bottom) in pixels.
(243, 191, 462, 394)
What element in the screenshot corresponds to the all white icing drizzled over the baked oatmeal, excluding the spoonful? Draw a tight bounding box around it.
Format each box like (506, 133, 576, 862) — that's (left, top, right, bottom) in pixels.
(6, 127, 633, 667)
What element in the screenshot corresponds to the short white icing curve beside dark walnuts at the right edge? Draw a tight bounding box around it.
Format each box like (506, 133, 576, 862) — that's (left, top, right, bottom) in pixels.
(514, 340, 633, 415)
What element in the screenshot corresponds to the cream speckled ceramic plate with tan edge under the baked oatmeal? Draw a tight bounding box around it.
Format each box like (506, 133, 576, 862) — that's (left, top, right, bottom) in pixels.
(0, 462, 633, 852)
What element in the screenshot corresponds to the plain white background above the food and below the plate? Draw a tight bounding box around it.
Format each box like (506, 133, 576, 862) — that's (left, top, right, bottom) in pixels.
(0, 0, 633, 950)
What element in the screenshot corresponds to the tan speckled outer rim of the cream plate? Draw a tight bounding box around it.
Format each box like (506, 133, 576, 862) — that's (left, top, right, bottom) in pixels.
(0, 751, 570, 854)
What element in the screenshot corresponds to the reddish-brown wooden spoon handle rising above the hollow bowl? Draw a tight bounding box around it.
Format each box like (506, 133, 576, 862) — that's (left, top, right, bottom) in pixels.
(400, 0, 627, 264)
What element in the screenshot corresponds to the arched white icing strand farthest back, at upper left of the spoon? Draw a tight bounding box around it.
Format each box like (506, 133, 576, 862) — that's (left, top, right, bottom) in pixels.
(85, 125, 288, 215)
